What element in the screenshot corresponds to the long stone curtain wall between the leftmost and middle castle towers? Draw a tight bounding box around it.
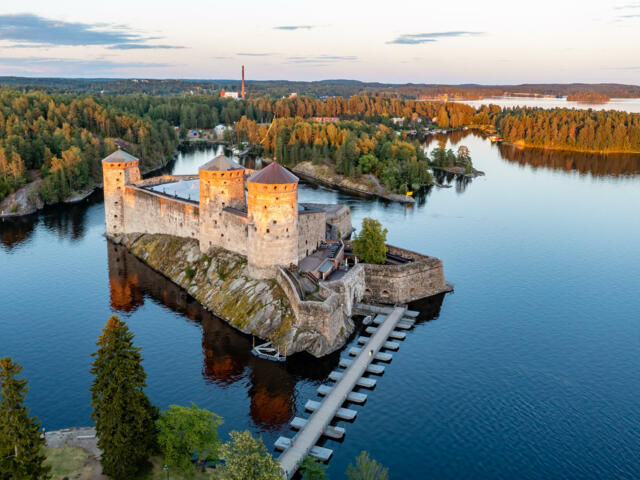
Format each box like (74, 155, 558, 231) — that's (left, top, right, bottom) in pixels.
(121, 186, 200, 239)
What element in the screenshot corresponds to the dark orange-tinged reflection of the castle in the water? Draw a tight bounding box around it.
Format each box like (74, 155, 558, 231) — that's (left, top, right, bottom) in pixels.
(107, 242, 444, 430)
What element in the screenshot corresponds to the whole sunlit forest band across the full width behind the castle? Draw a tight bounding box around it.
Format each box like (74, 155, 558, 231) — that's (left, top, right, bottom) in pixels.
(0, 86, 640, 208)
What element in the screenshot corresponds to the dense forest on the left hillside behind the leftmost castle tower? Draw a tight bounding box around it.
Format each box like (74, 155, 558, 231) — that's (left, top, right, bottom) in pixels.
(0, 90, 176, 203)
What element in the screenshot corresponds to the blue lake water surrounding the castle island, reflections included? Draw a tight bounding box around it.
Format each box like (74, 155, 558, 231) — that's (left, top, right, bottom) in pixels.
(0, 136, 640, 479)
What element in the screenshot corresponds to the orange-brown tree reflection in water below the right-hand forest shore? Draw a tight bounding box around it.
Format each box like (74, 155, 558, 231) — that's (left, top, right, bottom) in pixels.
(498, 144, 640, 177)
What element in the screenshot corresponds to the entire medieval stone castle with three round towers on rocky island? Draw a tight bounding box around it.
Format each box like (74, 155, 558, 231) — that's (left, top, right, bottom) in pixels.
(102, 150, 450, 354)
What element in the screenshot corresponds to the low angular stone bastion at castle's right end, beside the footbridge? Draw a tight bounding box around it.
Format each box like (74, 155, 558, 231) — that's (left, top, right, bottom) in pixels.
(362, 245, 451, 304)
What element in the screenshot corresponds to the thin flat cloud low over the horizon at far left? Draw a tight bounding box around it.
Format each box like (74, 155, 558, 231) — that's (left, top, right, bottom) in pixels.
(0, 57, 173, 76)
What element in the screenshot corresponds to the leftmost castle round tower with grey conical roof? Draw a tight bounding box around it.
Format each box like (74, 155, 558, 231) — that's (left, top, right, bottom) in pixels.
(102, 148, 140, 236)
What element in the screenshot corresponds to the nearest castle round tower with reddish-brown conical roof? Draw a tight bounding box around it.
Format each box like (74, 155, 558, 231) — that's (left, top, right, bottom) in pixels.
(247, 161, 298, 278)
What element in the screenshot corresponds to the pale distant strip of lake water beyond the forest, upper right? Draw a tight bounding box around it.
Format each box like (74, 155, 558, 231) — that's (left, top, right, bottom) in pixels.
(455, 97, 640, 113)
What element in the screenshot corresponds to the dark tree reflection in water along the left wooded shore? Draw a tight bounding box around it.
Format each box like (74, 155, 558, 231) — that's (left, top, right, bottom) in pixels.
(0, 192, 102, 248)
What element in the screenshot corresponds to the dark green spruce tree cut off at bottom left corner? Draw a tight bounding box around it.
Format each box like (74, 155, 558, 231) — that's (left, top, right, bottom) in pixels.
(0, 357, 51, 480)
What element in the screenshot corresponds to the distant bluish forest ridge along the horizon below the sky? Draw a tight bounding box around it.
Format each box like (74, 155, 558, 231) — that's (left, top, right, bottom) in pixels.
(0, 77, 640, 99)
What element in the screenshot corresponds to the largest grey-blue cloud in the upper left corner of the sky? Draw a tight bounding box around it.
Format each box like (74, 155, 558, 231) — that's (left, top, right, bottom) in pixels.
(0, 13, 184, 49)
